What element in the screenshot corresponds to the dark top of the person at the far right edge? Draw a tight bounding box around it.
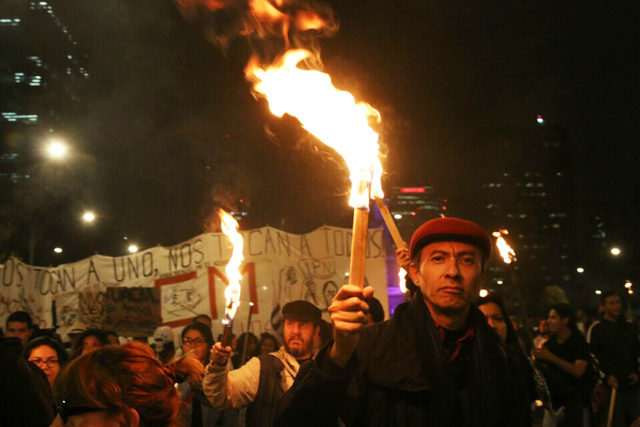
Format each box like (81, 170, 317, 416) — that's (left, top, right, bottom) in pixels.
(590, 316, 640, 388)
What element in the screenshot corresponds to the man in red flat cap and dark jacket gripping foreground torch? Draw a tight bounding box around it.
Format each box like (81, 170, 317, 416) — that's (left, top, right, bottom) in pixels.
(276, 218, 533, 426)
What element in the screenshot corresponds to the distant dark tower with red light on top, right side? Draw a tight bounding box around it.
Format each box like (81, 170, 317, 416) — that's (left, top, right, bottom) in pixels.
(483, 117, 576, 310)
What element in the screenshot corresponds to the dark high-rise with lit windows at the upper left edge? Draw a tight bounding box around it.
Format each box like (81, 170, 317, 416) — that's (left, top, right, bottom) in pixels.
(0, 0, 89, 261)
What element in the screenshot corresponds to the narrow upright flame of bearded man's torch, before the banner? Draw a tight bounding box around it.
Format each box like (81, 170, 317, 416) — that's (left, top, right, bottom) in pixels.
(218, 209, 244, 325)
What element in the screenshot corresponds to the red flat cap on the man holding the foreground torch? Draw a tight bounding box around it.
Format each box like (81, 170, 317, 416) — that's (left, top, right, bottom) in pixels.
(410, 218, 491, 260)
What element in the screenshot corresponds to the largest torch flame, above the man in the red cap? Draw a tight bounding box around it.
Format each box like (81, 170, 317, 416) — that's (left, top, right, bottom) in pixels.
(245, 49, 384, 210)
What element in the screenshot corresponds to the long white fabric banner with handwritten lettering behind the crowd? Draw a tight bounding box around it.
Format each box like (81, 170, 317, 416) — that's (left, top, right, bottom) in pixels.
(0, 227, 388, 342)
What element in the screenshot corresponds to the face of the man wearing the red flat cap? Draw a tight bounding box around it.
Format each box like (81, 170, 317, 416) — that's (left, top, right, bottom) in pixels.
(410, 242, 484, 315)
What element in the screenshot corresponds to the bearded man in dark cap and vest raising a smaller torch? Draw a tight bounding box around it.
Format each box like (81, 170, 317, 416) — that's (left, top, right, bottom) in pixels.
(202, 301, 322, 427)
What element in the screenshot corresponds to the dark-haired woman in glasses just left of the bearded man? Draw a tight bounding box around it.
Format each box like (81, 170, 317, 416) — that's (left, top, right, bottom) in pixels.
(178, 322, 237, 427)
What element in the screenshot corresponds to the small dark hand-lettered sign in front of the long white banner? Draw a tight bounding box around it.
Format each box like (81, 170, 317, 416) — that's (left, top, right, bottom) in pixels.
(101, 287, 162, 337)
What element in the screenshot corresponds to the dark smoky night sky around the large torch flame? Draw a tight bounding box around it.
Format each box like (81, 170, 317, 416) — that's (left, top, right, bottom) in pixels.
(45, 0, 640, 268)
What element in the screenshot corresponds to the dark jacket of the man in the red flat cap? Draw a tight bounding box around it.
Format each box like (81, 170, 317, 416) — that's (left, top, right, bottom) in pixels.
(276, 290, 532, 426)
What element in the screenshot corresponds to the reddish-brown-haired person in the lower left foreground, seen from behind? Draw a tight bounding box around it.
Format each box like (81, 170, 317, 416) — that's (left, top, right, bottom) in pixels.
(52, 342, 203, 427)
